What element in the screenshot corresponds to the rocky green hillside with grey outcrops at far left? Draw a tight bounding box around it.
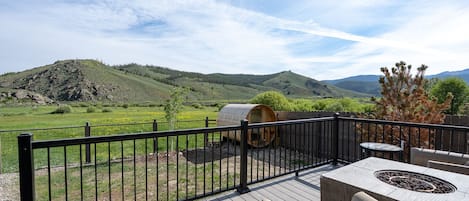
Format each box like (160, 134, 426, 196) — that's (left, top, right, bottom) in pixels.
(0, 60, 171, 101)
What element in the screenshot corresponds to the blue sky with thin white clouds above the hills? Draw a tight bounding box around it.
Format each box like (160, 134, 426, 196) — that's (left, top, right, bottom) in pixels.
(0, 0, 469, 80)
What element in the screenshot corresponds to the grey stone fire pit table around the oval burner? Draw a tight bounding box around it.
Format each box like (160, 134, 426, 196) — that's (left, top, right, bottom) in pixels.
(321, 157, 469, 201)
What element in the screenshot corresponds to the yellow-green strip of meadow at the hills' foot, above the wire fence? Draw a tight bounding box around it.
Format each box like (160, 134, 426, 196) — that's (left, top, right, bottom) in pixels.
(0, 106, 217, 130)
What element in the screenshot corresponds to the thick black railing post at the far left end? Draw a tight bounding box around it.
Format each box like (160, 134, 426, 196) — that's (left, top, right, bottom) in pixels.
(18, 133, 35, 201)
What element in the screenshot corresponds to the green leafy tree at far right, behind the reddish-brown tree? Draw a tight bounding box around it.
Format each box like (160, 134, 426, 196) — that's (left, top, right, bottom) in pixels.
(431, 77, 469, 114)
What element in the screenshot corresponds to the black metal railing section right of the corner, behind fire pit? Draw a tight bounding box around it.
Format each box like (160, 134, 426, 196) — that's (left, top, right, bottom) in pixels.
(337, 117, 469, 163)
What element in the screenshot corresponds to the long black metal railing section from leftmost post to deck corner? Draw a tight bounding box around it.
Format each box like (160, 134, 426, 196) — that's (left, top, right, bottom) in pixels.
(18, 117, 334, 200)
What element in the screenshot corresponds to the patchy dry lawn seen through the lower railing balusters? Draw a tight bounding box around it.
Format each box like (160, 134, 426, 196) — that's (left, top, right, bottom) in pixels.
(36, 148, 239, 200)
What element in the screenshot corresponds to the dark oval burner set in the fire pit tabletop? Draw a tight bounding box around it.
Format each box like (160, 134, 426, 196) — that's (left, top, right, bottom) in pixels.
(375, 170, 456, 193)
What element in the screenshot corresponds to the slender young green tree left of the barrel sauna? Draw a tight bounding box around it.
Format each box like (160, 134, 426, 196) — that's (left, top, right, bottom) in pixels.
(164, 87, 186, 130)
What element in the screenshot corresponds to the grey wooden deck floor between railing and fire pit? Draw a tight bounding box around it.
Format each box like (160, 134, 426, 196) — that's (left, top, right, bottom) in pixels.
(203, 165, 337, 201)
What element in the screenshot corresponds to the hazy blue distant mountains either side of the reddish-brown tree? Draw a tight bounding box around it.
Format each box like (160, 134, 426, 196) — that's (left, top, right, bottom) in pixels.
(322, 69, 469, 96)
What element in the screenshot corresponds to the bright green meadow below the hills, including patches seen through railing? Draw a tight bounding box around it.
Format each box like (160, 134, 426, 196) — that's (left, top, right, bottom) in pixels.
(0, 106, 217, 172)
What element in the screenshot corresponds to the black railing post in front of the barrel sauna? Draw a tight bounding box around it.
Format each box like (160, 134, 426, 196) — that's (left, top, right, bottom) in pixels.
(237, 119, 250, 194)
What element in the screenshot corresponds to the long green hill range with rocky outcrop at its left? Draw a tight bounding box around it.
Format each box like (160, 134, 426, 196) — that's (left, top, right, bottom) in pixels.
(0, 60, 367, 102)
